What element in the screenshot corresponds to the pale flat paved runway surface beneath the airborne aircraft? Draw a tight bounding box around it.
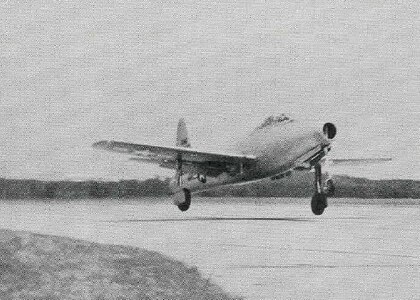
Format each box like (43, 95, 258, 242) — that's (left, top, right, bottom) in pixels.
(0, 199, 420, 299)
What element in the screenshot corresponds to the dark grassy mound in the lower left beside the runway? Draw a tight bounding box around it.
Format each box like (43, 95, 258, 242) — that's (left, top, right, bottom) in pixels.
(0, 230, 241, 300)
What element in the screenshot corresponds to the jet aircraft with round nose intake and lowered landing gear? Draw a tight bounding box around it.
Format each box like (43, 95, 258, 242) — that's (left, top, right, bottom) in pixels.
(93, 115, 388, 215)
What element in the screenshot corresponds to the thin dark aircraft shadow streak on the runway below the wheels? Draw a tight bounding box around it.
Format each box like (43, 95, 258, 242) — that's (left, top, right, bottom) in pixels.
(108, 217, 312, 223)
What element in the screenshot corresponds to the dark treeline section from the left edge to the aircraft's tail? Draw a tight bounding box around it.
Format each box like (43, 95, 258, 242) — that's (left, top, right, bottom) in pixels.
(0, 178, 169, 199)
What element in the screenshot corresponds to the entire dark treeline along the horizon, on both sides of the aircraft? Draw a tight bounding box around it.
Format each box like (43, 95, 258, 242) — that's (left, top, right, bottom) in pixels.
(0, 172, 420, 199)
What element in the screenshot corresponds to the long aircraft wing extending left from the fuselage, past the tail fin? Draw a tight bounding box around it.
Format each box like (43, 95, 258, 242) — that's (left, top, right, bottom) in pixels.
(92, 141, 255, 175)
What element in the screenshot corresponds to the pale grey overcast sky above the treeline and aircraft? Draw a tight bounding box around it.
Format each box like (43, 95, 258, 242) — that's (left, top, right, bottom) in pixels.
(0, 0, 420, 179)
